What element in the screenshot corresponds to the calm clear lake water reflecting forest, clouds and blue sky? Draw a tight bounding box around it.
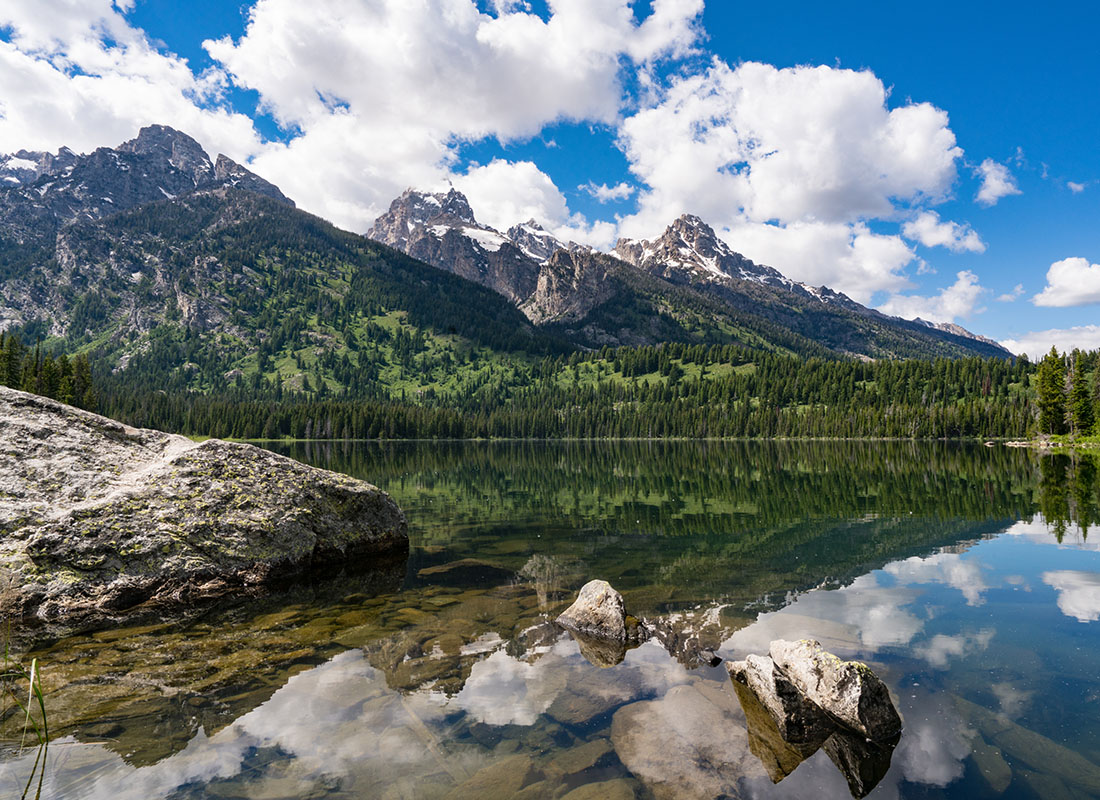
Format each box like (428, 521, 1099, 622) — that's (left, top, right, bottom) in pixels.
(0, 442, 1100, 800)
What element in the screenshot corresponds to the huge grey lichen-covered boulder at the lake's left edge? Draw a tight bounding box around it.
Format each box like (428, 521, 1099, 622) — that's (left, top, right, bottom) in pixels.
(0, 387, 408, 622)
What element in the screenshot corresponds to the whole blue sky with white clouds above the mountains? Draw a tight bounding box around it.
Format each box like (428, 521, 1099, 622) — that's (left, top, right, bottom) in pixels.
(0, 0, 1100, 355)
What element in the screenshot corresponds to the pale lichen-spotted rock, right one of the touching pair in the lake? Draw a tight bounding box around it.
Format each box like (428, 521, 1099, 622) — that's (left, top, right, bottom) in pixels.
(769, 639, 901, 742)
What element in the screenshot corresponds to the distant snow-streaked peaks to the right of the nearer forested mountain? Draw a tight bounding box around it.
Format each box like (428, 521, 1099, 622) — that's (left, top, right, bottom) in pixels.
(366, 188, 1008, 358)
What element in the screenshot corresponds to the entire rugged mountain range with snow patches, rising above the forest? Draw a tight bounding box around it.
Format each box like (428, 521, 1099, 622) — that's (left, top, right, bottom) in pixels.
(0, 125, 1009, 400)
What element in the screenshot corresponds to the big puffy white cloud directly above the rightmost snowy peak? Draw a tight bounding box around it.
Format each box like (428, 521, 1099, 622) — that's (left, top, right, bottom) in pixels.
(618, 59, 972, 302)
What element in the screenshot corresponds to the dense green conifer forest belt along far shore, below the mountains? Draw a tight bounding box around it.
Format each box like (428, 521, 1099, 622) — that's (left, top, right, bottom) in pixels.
(102, 343, 1034, 439)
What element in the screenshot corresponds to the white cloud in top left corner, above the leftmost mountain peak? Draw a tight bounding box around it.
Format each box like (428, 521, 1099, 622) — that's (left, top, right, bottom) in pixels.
(0, 0, 260, 160)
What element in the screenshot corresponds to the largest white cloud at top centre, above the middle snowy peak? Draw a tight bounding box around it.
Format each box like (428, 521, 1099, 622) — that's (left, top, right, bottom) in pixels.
(205, 0, 702, 230)
